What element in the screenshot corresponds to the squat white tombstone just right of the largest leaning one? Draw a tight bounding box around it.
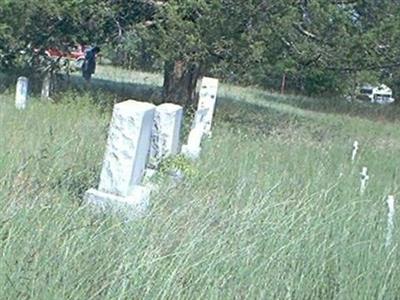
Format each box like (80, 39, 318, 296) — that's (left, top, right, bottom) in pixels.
(149, 103, 183, 168)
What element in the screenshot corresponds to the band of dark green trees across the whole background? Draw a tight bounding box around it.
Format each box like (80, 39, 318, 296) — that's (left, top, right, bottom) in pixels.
(0, 0, 400, 105)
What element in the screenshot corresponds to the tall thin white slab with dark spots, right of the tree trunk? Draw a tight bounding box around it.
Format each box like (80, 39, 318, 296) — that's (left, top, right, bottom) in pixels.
(197, 77, 218, 136)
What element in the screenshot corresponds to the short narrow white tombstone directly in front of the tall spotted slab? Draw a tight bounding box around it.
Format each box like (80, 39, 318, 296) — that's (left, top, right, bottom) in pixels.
(182, 109, 208, 159)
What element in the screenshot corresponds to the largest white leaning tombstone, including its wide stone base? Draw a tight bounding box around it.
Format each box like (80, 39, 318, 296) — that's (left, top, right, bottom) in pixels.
(85, 100, 155, 216)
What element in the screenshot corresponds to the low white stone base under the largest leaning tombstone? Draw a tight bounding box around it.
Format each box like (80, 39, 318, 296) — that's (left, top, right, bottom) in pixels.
(85, 185, 151, 218)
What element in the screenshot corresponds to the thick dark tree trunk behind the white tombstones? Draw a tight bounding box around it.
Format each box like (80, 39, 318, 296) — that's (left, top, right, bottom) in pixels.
(162, 60, 200, 108)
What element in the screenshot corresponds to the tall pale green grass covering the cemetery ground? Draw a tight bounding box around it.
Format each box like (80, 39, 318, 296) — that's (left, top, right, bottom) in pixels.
(0, 67, 400, 299)
